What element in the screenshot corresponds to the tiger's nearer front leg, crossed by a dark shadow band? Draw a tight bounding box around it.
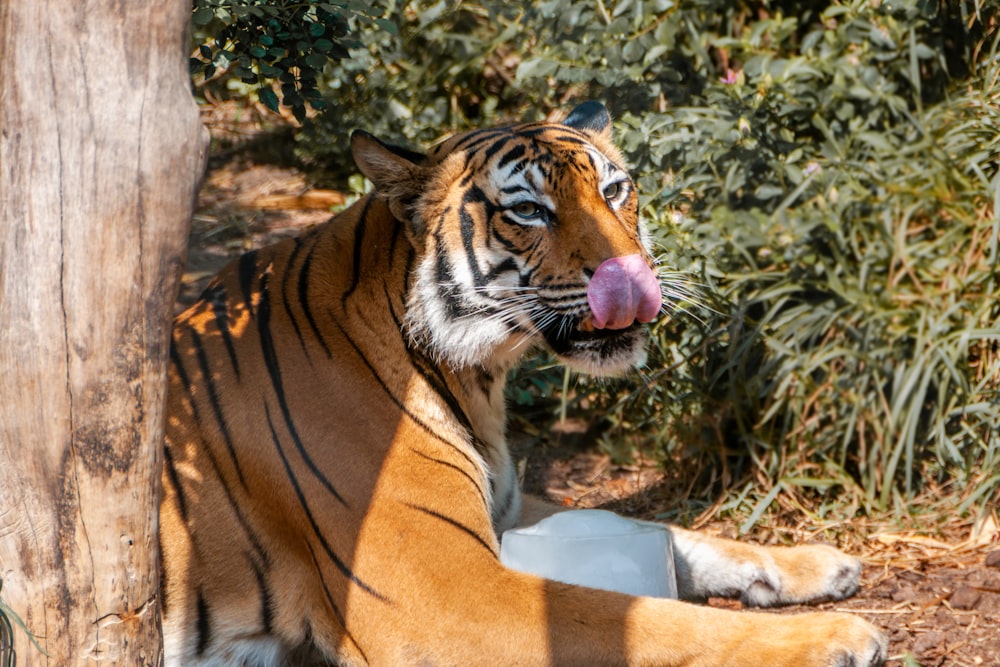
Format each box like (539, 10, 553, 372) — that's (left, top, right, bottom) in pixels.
(340, 448, 885, 667)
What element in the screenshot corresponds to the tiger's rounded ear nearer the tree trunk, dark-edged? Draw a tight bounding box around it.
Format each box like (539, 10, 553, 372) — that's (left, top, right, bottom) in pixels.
(351, 130, 426, 227)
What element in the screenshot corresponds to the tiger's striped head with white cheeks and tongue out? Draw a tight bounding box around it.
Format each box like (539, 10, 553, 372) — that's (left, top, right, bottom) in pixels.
(351, 102, 661, 375)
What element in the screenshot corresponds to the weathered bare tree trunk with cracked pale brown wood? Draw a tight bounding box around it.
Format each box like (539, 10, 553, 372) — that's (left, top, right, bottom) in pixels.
(0, 0, 206, 667)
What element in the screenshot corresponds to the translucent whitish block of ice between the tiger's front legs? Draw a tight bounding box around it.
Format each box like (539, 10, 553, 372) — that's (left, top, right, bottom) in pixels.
(500, 510, 677, 598)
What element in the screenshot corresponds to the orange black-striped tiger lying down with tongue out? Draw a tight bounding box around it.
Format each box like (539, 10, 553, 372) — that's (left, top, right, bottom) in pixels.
(160, 101, 886, 667)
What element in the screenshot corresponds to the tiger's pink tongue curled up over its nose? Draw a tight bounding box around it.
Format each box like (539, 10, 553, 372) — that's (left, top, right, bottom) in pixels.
(587, 255, 662, 329)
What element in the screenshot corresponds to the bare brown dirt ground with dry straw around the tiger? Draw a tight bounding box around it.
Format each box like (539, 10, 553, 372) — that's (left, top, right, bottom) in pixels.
(184, 102, 1000, 667)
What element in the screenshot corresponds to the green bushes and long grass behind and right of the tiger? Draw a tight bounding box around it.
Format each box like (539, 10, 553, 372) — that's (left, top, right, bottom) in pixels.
(191, 0, 1000, 528)
